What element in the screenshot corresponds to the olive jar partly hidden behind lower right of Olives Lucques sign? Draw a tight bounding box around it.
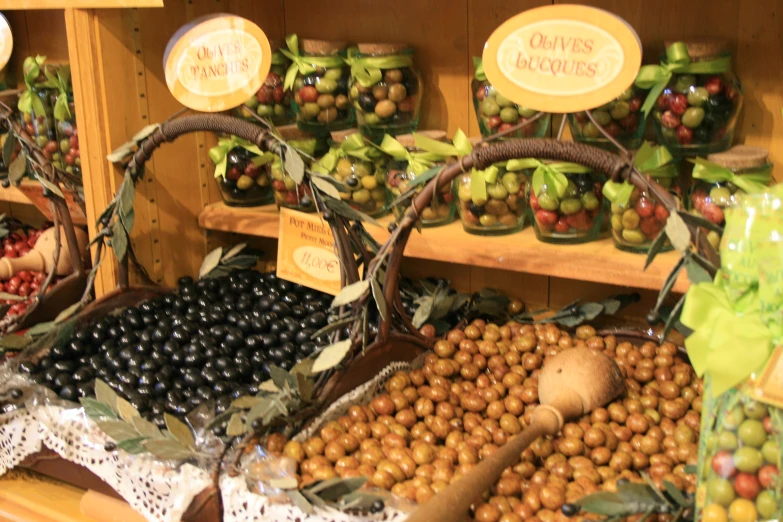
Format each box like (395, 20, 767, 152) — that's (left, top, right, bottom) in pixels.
(568, 86, 646, 151)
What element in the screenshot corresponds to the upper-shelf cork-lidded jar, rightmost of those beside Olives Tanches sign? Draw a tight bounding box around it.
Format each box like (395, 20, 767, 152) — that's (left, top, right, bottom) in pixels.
(348, 44, 422, 143)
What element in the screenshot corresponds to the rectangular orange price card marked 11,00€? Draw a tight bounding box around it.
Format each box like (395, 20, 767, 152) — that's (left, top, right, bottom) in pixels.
(277, 207, 341, 295)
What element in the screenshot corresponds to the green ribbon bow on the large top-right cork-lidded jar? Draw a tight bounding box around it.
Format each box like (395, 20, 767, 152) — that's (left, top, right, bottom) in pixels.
(636, 42, 731, 117)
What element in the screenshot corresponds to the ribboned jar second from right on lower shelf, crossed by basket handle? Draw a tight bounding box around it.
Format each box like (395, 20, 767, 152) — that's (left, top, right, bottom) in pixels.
(603, 142, 681, 253)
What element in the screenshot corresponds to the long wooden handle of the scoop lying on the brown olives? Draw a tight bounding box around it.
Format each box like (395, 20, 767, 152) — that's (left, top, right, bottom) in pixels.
(406, 418, 559, 522)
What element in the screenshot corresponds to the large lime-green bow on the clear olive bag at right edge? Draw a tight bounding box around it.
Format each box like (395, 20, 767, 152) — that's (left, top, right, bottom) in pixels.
(680, 272, 781, 396)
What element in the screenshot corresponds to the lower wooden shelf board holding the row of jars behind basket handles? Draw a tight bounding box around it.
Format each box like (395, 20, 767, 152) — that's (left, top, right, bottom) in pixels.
(198, 203, 688, 292)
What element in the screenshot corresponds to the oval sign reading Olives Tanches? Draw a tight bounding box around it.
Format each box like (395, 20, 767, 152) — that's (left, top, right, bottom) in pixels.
(163, 14, 272, 112)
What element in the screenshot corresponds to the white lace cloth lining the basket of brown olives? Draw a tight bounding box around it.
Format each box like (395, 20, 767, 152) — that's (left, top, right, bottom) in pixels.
(220, 362, 411, 522)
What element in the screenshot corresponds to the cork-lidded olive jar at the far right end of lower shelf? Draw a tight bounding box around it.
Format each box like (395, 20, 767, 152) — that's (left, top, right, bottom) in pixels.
(690, 145, 772, 248)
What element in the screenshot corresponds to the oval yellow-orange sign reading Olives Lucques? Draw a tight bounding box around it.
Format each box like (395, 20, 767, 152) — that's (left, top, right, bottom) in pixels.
(484, 5, 642, 113)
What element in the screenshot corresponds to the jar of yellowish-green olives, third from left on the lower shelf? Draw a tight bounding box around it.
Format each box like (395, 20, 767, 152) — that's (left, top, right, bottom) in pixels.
(313, 129, 387, 217)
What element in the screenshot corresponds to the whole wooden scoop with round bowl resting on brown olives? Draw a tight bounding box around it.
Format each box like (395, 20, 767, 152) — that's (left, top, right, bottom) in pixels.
(406, 348, 625, 522)
